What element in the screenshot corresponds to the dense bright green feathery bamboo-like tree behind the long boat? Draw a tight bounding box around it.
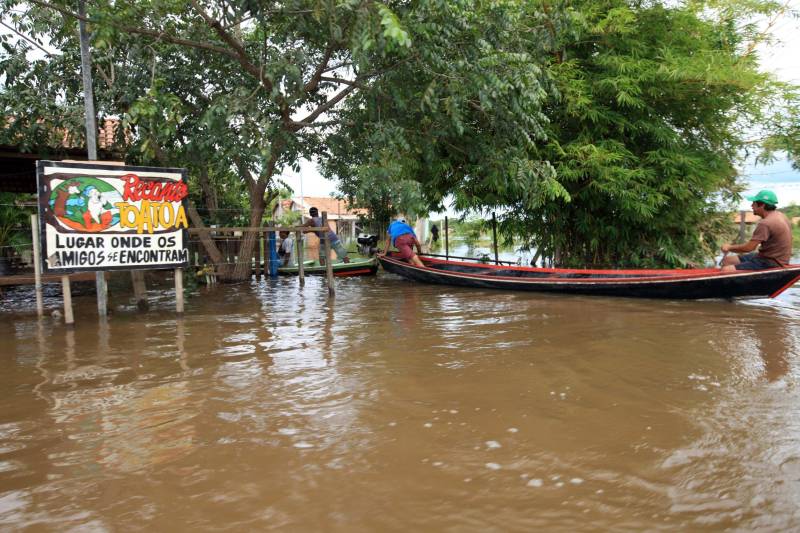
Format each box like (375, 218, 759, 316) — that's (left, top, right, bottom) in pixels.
(502, 0, 784, 267)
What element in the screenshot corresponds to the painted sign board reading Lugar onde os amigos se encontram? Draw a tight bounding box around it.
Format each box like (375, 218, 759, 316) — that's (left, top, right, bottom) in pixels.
(36, 161, 189, 273)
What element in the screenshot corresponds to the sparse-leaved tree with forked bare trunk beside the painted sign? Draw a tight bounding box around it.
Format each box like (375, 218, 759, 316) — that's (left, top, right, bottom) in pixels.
(2, 0, 418, 280)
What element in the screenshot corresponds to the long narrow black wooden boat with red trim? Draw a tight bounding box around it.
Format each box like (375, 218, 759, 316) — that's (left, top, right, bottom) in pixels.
(378, 251, 800, 299)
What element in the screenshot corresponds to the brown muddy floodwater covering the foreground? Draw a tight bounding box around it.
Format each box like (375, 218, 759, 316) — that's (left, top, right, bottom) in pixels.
(0, 274, 800, 532)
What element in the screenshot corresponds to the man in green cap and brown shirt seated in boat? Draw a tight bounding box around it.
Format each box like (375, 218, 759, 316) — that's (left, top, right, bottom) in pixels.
(722, 190, 792, 270)
